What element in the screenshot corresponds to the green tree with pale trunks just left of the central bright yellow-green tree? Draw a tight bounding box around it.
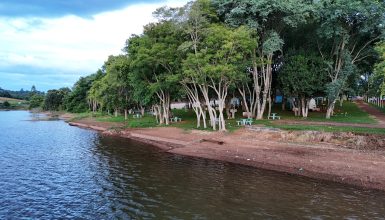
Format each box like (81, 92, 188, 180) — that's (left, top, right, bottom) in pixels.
(126, 21, 182, 125)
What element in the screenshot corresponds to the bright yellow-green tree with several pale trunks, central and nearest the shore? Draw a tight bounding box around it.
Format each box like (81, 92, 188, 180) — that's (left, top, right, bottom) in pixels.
(183, 24, 255, 130)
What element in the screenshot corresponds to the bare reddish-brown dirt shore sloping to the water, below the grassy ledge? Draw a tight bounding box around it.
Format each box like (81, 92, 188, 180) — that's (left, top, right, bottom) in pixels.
(67, 117, 385, 191)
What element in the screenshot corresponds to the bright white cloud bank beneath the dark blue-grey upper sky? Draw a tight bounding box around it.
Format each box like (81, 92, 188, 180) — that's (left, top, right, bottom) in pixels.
(0, 0, 187, 90)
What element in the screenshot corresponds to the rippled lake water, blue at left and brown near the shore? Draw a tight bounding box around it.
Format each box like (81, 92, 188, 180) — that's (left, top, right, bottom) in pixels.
(0, 111, 385, 219)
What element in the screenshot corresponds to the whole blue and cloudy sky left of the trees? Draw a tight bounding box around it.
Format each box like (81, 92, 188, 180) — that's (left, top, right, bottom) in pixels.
(0, 0, 187, 91)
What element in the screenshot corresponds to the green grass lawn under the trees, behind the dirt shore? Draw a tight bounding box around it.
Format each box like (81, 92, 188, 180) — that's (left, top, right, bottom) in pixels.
(77, 102, 385, 134)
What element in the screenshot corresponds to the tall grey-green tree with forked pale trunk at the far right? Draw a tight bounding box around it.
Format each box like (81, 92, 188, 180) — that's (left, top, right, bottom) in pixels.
(316, 0, 385, 118)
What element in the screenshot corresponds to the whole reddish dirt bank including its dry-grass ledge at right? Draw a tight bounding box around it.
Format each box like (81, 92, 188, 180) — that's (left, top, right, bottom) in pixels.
(70, 119, 385, 190)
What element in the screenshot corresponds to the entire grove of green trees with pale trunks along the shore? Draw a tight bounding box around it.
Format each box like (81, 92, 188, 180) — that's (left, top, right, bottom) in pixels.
(34, 0, 385, 130)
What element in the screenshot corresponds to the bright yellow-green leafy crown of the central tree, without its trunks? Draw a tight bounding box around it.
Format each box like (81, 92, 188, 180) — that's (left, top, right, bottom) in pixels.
(183, 25, 256, 84)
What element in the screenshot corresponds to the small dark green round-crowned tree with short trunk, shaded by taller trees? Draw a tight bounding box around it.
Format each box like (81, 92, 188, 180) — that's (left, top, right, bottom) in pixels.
(279, 52, 326, 118)
